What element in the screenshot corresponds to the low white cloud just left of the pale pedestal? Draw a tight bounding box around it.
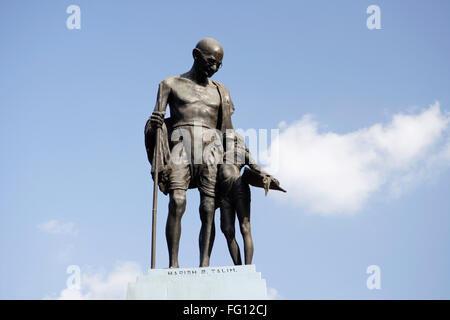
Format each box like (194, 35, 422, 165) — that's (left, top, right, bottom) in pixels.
(55, 261, 142, 300)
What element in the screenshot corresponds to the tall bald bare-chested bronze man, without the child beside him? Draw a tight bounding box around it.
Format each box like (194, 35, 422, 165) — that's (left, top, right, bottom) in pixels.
(146, 38, 234, 268)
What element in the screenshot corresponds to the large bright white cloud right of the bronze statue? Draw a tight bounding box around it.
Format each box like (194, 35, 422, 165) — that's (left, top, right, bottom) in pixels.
(266, 102, 450, 214)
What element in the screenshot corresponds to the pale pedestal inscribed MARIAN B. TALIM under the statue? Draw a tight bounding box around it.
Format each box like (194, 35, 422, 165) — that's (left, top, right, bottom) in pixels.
(127, 265, 267, 300)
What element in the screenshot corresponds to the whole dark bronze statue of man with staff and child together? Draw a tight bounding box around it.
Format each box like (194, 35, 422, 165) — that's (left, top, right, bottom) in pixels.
(145, 38, 284, 268)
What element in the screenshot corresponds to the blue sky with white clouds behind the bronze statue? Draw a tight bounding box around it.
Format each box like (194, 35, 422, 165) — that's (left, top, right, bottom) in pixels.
(0, 0, 450, 299)
